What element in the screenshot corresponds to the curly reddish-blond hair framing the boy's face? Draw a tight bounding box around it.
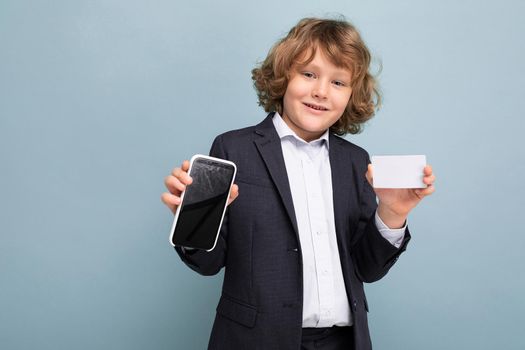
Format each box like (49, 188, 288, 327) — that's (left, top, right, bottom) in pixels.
(252, 18, 381, 135)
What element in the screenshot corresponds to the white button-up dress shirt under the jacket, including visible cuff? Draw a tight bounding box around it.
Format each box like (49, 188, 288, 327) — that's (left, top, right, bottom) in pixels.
(273, 113, 406, 328)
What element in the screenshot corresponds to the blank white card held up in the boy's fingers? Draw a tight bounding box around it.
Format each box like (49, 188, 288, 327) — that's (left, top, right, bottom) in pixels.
(372, 155, 427, 188)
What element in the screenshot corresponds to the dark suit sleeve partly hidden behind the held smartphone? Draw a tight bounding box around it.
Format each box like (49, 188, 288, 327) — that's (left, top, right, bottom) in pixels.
(175, 136, 228, 276)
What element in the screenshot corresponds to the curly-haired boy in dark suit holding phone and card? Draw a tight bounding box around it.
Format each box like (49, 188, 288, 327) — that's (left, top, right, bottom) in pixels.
(162, 18, 434, 350)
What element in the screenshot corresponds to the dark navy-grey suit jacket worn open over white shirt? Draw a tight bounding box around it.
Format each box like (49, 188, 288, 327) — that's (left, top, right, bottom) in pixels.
(177, 114, 410, 350)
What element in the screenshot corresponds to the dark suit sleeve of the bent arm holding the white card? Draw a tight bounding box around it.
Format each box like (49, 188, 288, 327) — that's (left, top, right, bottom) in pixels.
(352, 154, 410, 283)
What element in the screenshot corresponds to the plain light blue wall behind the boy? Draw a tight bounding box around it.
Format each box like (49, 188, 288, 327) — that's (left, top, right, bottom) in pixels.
(0, 0, 525, 350)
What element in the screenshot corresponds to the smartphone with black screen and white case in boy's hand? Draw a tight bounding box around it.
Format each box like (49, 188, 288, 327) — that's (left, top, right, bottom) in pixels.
(170, 154, 237, 251)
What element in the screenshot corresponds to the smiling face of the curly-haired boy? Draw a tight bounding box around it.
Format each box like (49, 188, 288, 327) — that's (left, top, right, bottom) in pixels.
(282, 49, 352, 142)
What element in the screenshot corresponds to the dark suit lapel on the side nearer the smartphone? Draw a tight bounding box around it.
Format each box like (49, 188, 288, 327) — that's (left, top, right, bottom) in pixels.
(254, 113, 299, 237)
